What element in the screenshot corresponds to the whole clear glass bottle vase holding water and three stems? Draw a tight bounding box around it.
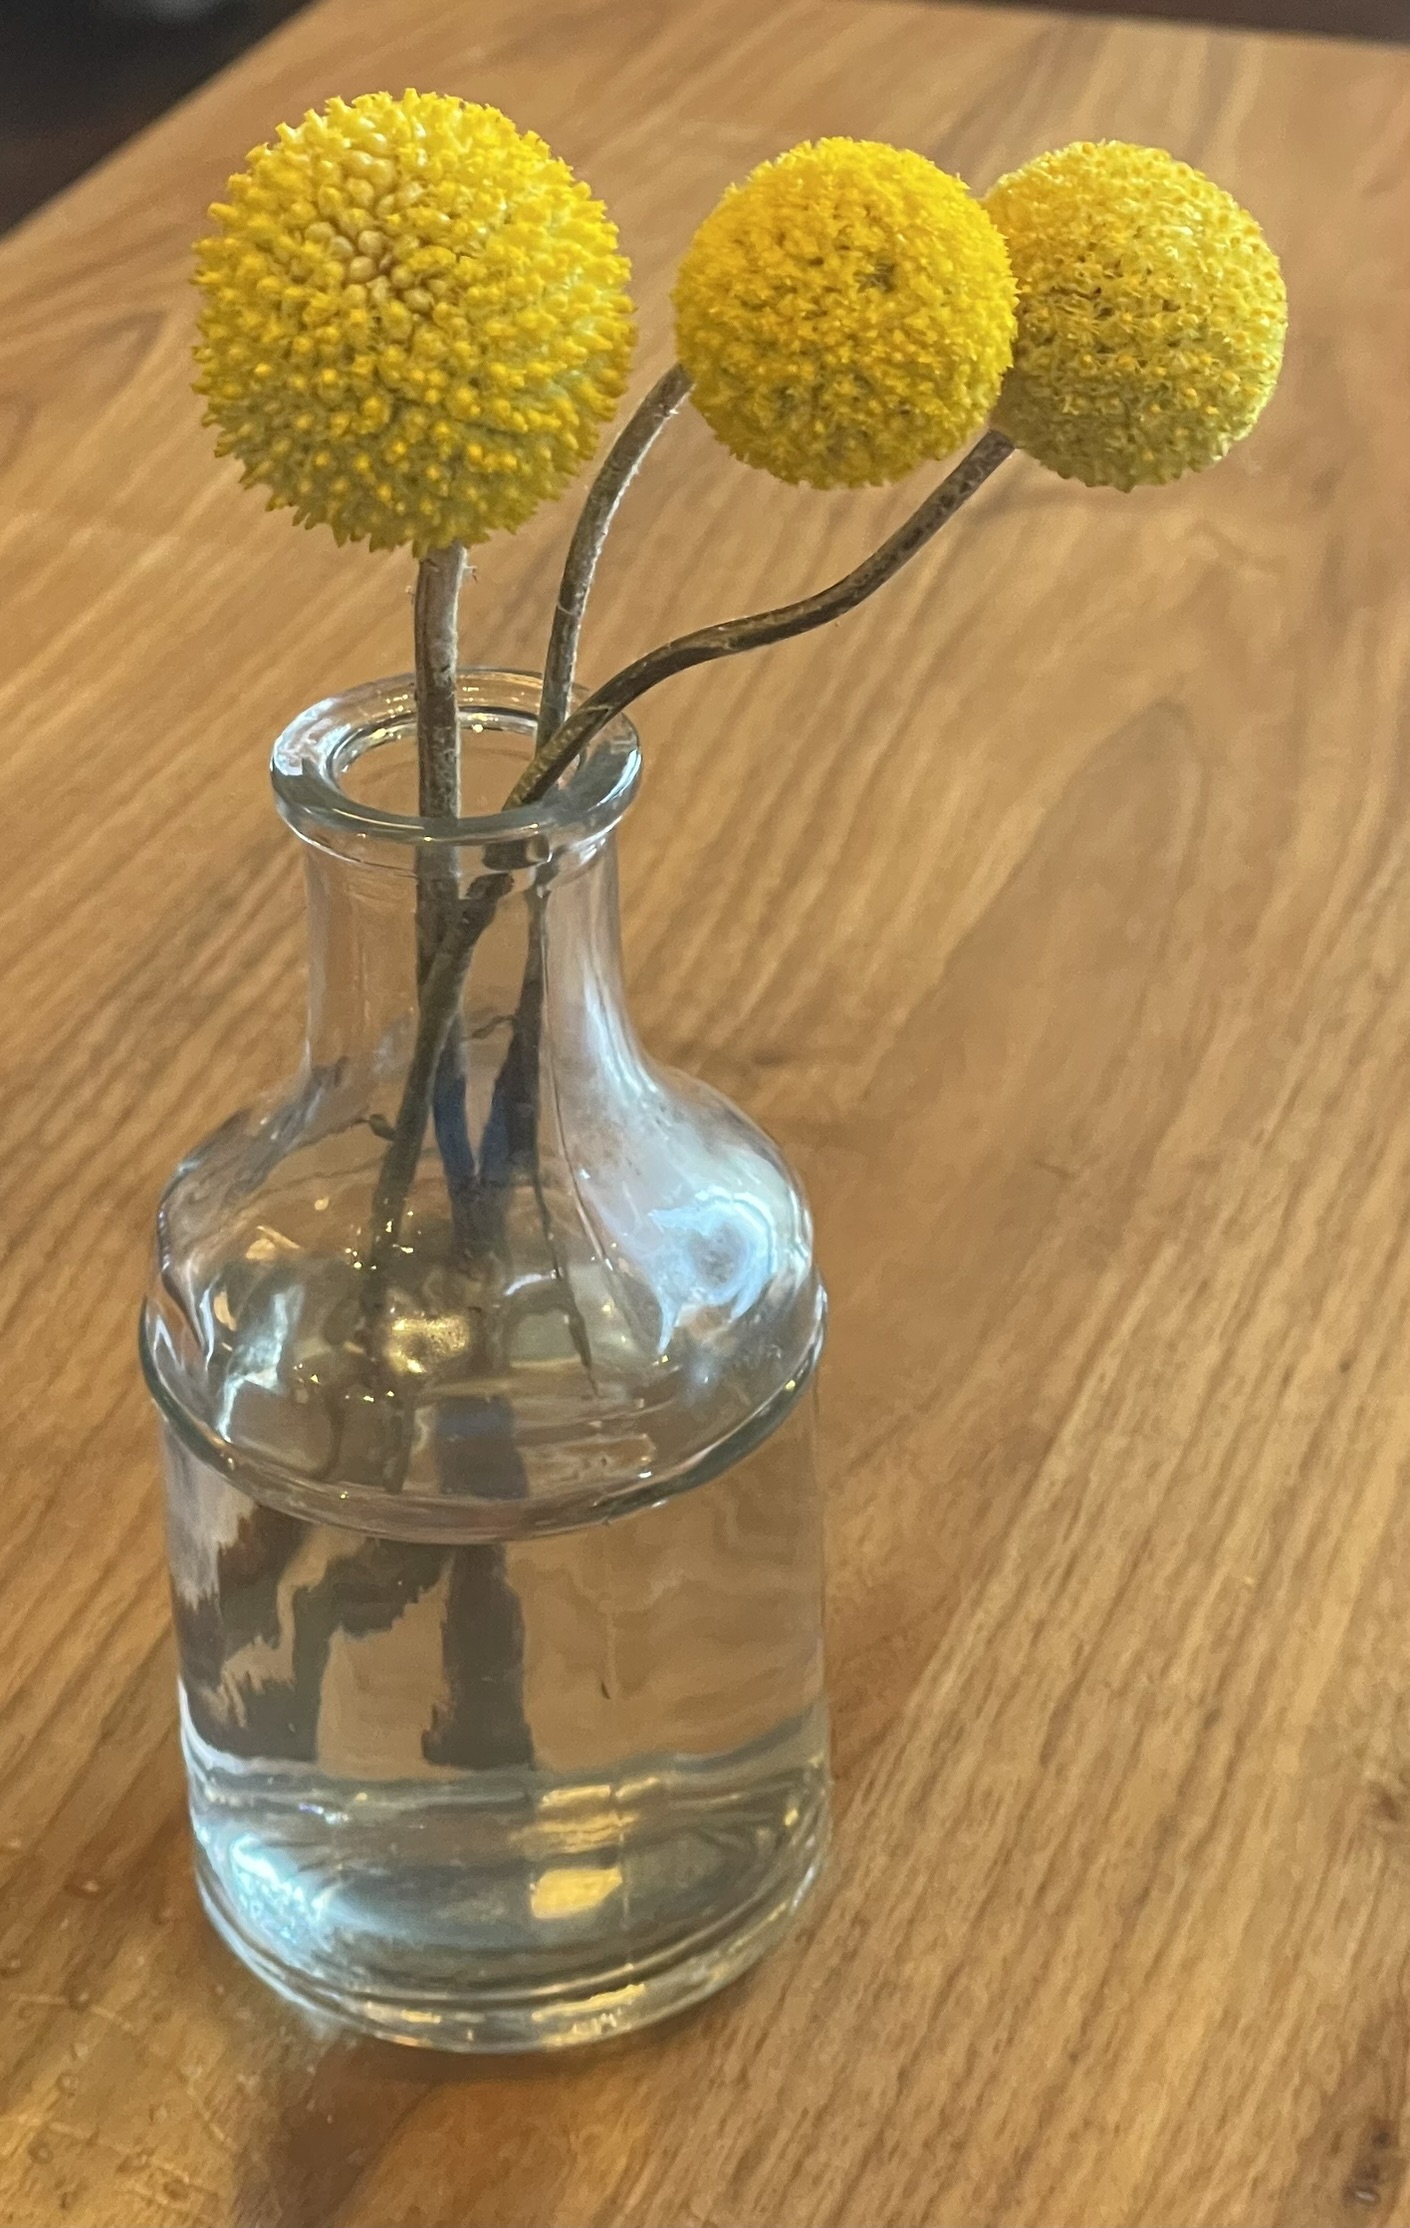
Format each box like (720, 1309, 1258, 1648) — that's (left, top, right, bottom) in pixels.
(143, 673, 826, 2050)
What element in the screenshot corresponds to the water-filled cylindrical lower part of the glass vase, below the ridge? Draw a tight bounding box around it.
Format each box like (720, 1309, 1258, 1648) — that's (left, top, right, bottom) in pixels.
(165, 1388, 826, 2050)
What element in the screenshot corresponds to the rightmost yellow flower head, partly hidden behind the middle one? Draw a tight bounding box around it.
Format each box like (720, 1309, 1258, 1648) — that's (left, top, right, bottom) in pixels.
(985, 140, 1287, 488)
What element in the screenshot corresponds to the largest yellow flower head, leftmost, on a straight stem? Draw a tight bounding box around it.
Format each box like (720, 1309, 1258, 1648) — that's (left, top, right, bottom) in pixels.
(196, 94, 635, 557)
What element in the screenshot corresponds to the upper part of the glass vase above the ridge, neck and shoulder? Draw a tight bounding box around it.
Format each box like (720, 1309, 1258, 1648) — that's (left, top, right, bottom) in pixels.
(143, 677, 824, 1540)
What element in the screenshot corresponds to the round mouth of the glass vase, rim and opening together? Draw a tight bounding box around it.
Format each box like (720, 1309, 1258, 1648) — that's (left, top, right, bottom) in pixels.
(270, 666, 642, 871)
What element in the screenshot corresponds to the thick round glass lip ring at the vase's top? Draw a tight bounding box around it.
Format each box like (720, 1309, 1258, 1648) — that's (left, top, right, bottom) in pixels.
(270, 666, 642, 867)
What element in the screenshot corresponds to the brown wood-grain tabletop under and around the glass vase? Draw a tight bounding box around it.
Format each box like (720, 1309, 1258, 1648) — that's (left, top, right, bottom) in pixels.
(0, 0, 1410, 2228)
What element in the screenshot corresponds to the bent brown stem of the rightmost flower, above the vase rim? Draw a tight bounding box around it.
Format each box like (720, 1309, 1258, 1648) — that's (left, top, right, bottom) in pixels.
(503, 432, 1014, 811)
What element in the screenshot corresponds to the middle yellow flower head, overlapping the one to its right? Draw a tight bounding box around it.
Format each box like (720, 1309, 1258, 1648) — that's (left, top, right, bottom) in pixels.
(675, 138, 1014, 488)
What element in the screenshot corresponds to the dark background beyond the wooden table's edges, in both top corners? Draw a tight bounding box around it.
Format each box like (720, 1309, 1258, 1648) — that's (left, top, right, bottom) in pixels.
(0, 0, 1410, 232)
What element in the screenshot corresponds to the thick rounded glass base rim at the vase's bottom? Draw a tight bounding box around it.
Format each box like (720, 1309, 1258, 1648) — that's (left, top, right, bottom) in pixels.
(196, 1800, 829, 2054)
